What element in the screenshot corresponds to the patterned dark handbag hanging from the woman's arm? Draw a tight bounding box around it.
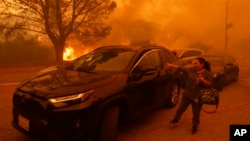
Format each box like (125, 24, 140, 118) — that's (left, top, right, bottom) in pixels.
(198, 88, 220, 113)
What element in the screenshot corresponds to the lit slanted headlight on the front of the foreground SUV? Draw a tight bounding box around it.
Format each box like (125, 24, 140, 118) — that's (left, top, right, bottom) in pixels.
(49, 90, 94, 108)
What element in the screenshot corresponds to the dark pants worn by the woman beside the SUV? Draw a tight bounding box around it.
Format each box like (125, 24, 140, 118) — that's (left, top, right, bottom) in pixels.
(174, 96, 202, 126)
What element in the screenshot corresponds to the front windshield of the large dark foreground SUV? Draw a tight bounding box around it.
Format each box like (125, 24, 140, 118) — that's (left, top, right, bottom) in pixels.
(67, 49, 135, 72)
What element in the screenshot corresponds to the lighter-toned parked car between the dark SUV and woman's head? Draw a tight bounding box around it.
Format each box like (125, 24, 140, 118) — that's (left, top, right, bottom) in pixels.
(172, 48, 204, 65)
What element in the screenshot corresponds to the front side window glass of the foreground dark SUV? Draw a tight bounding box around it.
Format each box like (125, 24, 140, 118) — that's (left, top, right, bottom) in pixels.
(136, 51, 161, 68)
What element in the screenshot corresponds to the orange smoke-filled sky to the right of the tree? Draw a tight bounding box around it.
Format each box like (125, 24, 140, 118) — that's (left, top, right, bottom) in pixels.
(100, 0, 250, 56)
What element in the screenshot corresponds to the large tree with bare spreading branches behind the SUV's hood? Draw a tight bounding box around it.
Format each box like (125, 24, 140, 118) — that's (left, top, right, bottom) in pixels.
(0, 0, 116, 63)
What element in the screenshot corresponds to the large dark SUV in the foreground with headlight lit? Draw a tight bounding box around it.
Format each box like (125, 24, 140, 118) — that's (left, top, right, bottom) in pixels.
(13, 46, 180, 141)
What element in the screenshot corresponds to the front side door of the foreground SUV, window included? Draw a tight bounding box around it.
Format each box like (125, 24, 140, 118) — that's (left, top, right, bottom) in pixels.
(127, 50, 163, 113)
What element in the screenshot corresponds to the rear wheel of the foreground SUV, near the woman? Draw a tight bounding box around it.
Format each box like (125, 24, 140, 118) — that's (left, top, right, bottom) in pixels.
(165, 82, 180, 107)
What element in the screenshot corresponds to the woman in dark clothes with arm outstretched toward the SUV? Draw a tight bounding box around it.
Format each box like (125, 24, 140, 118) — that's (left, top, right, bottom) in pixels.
(167, 57, 212, 134)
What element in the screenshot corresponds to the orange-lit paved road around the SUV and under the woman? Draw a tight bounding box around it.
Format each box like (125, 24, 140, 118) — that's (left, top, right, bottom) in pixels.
(0, 60, 250, 141)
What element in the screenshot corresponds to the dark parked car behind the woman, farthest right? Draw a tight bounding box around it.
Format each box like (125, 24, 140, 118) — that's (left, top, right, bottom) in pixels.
(201, 54, 240, 90)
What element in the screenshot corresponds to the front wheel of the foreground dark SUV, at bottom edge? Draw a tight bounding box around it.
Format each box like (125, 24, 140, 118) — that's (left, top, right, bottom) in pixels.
(98, 106, 120, 141)
